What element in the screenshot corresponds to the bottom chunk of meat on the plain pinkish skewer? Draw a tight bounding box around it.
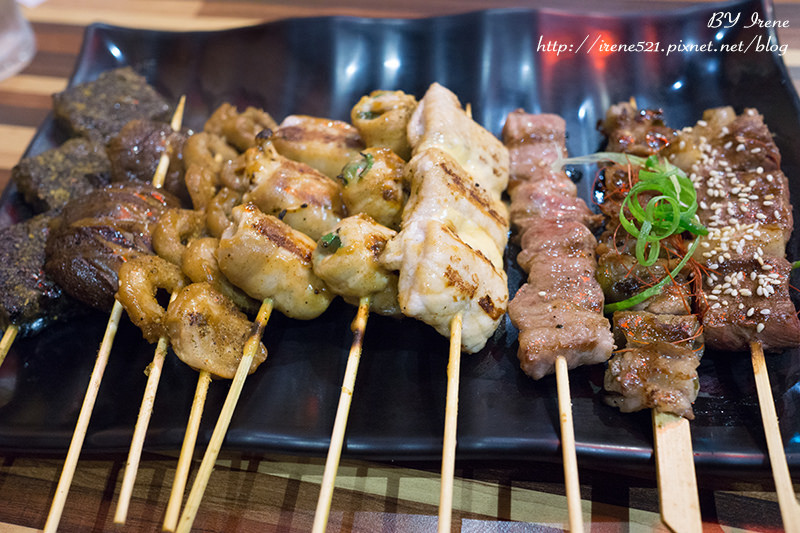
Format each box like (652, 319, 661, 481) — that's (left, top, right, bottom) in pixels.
(508, 294, 614, 379)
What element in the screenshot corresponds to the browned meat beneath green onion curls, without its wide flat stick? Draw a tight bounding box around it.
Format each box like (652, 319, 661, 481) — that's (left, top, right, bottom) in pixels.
(598, 98, 703, 419)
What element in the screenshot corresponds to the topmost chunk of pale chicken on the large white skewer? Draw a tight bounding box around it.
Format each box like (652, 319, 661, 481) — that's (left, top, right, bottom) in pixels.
(408, 83, 509, 198)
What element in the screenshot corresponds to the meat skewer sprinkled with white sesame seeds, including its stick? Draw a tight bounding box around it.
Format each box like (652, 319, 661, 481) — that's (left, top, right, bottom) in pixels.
(667, 107, 800, 531)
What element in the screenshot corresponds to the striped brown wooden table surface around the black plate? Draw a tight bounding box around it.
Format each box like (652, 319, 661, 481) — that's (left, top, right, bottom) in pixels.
(0, 0, 800, 532)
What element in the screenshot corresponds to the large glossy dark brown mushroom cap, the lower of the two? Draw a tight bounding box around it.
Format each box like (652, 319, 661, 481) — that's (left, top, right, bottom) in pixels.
(45, 184, 179, 311)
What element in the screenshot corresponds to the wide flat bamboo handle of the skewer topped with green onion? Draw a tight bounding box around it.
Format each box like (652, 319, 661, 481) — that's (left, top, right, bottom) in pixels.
(651, 409, 703, 533)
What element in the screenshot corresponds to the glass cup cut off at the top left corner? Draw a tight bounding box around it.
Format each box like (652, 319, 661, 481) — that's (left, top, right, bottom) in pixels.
(0, 0, 36, 80)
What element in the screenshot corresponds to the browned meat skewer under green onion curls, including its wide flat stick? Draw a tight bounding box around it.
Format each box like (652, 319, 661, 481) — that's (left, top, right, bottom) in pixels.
(598, 103, 702, 531)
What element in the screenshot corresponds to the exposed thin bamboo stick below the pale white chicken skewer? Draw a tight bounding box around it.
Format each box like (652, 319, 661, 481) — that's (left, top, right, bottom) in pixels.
(438, 313, 462, 533)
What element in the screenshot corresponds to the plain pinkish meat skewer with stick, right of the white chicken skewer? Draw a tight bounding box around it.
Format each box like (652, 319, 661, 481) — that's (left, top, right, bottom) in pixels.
(503, 110, 614, 531)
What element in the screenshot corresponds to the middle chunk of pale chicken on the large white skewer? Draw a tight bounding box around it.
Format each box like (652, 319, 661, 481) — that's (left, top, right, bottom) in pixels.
(401, 148, 508, 270)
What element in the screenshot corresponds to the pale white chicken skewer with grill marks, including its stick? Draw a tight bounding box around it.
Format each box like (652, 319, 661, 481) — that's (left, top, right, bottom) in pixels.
(382, 83, 508, 531)
